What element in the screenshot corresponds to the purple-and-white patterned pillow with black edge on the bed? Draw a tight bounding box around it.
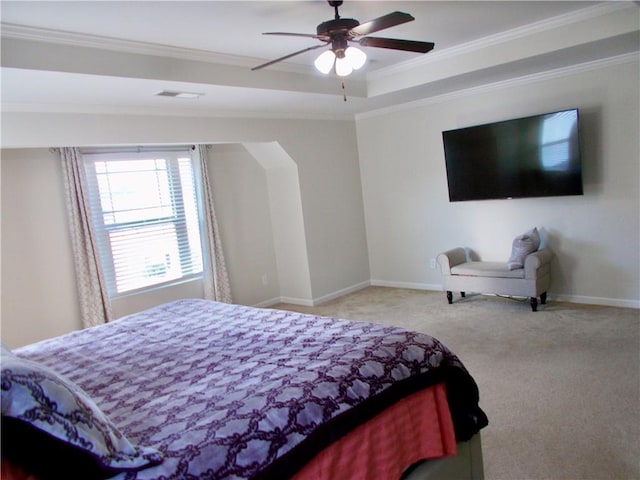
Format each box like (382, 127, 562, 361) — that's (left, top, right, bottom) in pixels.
(1, 348, 162, 479)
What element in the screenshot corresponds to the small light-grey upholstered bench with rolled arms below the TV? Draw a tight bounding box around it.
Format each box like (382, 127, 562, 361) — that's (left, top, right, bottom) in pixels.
(437, 229, 553, 312)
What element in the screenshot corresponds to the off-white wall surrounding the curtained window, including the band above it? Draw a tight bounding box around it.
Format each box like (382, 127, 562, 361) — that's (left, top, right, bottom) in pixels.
(0, 116, 369, 347)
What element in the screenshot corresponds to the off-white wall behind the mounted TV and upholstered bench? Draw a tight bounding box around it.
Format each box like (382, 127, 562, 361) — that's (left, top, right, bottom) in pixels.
(357, 57, 640, 308)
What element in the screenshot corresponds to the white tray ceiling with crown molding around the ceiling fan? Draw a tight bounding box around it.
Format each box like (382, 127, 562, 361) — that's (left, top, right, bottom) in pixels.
(0, 0, 640, 117)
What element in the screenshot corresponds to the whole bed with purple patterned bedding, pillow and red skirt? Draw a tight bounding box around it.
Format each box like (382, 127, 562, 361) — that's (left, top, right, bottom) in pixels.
(2, 299, 488, 480)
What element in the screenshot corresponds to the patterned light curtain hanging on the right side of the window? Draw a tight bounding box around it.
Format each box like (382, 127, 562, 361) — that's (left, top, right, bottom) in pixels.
(196, 145, 231, 303)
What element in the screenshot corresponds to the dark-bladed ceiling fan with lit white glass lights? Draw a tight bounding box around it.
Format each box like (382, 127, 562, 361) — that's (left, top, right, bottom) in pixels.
(251, 0, 434, 76)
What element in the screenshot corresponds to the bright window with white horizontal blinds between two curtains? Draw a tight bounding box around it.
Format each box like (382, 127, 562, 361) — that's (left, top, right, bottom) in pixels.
(83, 151, 202, 297)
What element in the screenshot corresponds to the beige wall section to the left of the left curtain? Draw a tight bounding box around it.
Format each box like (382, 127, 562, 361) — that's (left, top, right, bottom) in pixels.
(0, 149, 81, 347)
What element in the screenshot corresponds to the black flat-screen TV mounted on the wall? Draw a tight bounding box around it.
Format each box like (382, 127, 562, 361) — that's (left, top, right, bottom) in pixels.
(442, 109, 583, 202)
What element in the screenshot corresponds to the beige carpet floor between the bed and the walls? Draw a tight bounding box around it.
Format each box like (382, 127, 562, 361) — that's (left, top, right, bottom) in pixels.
(275, 287, 640, 480)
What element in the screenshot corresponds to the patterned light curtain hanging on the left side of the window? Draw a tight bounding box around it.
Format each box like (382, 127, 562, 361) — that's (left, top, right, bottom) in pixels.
(60, 148, 112, 327)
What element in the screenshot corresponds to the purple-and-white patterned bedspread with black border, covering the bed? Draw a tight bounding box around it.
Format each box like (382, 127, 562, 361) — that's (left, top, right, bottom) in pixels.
(15, 300, 486, 480)
